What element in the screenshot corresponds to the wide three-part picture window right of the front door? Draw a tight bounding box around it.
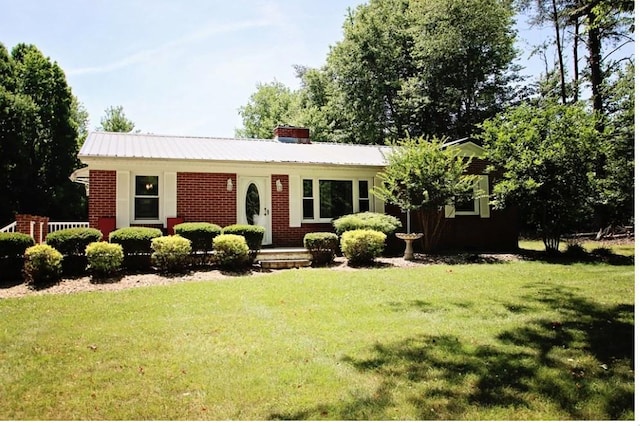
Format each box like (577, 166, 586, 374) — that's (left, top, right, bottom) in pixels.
(302, 179, 372, 222)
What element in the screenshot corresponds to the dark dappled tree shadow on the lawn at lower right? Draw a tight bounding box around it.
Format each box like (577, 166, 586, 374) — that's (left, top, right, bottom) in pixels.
(270, 284, 634, 420)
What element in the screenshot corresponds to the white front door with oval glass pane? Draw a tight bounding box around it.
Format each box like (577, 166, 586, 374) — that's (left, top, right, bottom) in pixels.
(238, 176, 271, 245)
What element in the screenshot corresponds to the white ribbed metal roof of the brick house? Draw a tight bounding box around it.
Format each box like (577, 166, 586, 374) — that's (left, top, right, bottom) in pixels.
(78, 132, 391, 166)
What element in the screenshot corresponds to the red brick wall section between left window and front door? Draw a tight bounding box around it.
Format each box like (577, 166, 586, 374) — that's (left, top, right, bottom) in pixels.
(177, 172, 238, 227)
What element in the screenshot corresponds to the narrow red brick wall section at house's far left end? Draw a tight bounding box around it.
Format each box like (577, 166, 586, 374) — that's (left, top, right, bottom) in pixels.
(89, 170, 116, 229)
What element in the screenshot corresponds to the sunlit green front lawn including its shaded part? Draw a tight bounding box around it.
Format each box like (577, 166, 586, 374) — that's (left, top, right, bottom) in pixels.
(0, 256, 634, 420)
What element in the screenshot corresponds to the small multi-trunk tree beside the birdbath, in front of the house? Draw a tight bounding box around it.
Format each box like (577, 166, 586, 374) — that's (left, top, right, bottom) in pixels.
(373, 137, 473, 251)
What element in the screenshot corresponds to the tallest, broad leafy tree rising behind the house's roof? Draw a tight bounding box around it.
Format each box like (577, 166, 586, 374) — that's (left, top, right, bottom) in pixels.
(326, 0, 516, 144)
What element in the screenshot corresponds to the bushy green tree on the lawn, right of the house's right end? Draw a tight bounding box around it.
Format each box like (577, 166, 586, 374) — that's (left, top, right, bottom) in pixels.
(481, 103, 602, 252)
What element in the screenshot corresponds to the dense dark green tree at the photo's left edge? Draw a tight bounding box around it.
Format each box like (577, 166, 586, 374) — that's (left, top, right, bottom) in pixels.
(0, 43, 85, 223)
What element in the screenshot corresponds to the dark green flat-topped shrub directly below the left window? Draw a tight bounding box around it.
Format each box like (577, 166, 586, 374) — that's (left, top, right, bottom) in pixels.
(109, 226, 162, 270)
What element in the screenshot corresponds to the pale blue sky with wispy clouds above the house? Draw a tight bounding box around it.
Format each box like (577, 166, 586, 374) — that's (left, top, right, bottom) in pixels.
(0, 0, 592, 137)
